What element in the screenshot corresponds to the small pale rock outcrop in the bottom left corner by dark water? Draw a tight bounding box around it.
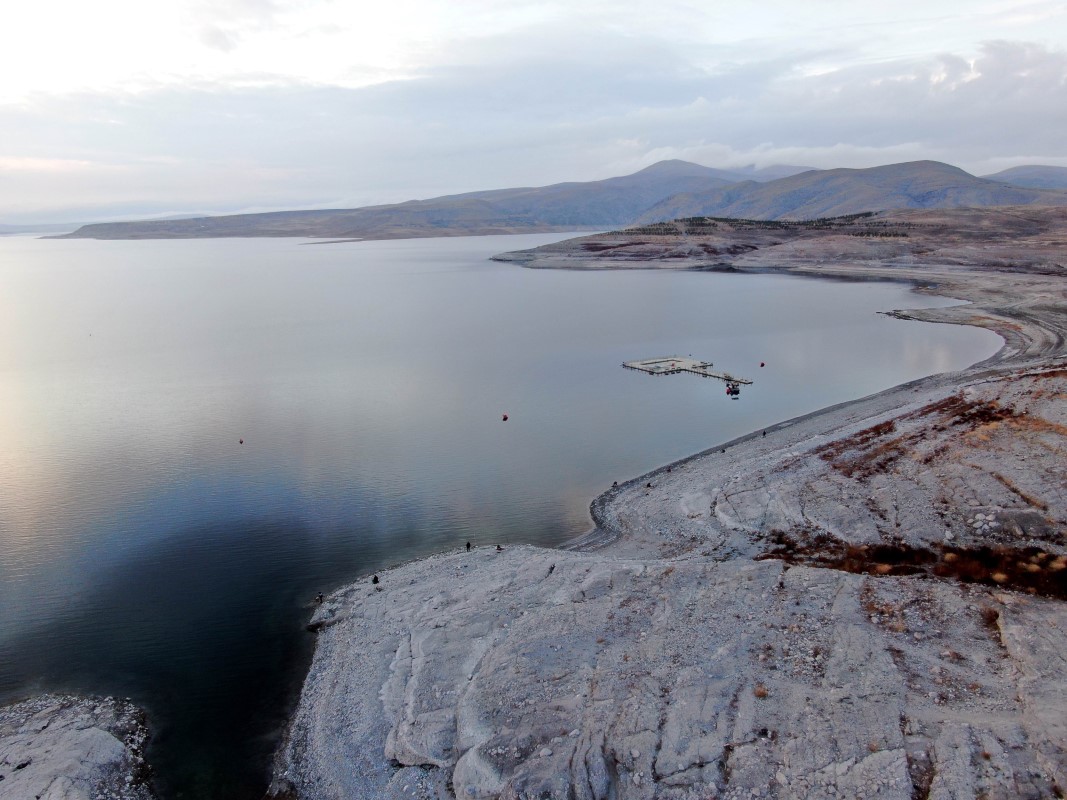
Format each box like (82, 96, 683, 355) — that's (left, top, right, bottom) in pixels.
(0, 694, 154, 800)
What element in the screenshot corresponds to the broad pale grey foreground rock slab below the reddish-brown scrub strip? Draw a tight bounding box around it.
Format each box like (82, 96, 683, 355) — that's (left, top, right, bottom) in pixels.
(276, 535, 1067, 798)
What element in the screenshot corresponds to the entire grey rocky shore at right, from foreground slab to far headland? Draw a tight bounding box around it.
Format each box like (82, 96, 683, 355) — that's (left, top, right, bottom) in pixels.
(270, 209, 1067, 800)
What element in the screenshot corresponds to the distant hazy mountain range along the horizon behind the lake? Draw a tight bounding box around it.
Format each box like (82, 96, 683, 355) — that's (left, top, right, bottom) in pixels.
(60, 160, 1067, 239)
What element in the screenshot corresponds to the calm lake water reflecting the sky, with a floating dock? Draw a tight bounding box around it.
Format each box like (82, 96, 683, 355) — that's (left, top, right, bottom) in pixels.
(0, 235, 1000, 800)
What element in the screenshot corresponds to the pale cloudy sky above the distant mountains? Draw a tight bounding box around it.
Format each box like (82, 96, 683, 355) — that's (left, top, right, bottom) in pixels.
(0, 0, 1067, 224)
